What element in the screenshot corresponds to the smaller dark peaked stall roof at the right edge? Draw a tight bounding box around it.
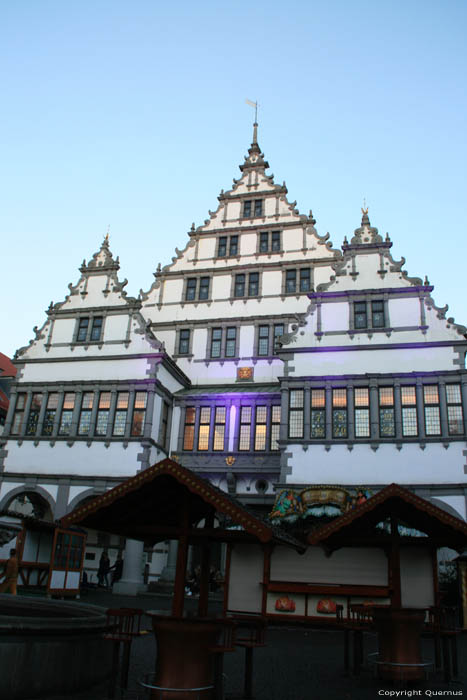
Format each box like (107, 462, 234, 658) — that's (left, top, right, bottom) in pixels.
(308, 484, 467, 551)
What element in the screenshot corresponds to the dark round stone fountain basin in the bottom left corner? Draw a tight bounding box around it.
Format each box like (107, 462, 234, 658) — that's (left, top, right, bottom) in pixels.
(0, 594, 112, 700)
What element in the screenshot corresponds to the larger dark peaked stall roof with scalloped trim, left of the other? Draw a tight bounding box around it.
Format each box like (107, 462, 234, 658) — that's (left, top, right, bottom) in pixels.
(61, 459, 306, 551)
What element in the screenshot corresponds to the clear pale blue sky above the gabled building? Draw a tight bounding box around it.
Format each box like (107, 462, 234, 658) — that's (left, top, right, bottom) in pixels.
(0, 0, 467, 355)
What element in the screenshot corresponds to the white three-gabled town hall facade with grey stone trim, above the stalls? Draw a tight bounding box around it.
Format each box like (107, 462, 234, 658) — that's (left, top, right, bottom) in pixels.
(0, 125, 467, 584)
